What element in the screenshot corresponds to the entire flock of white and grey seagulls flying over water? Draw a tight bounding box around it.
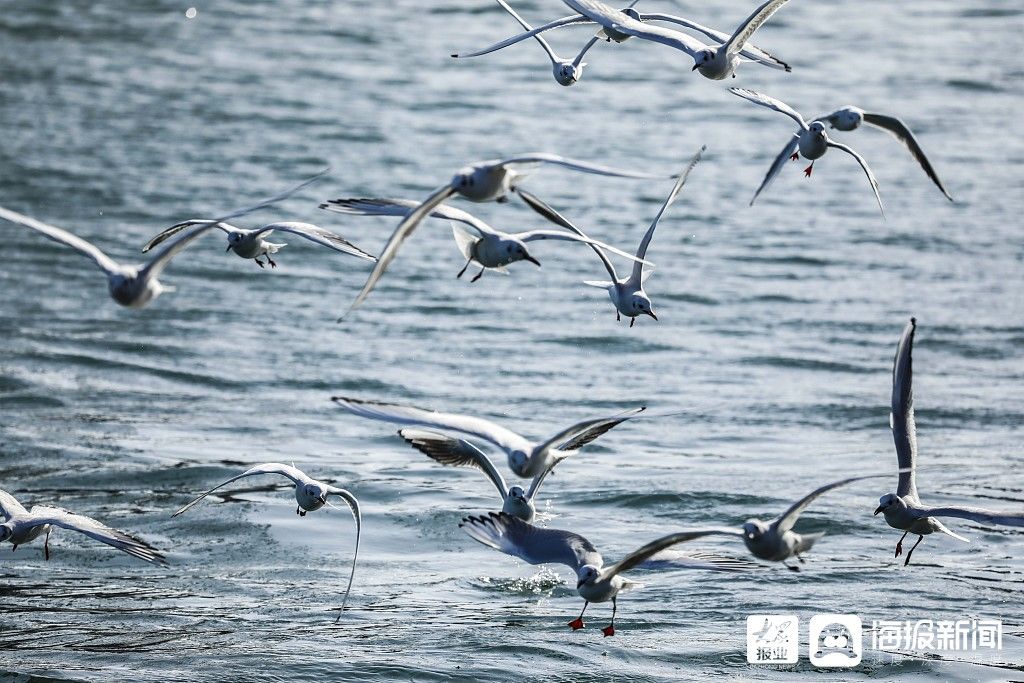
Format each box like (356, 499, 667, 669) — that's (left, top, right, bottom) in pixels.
(0, 0, 1024, 636)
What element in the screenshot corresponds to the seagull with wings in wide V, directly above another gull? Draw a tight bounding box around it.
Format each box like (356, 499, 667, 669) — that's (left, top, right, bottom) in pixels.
(331, 396, 646, 478)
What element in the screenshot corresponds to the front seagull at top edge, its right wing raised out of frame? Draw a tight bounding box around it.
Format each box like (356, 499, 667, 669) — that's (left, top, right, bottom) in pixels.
(562, 0, 791, 81)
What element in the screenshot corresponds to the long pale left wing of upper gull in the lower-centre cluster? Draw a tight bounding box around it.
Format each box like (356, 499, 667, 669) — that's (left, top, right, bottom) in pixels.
(331, 396, 532, 453)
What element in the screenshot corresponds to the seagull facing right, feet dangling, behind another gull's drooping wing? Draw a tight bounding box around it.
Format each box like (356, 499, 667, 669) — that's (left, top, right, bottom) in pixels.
(321, 197, 650, 283)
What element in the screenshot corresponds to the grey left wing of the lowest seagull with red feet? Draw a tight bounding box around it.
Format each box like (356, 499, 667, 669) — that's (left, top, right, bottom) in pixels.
(459, 512, 603, 571)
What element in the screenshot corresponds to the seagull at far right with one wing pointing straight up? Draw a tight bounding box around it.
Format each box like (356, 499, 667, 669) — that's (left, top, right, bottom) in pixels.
(874, 317, 1024, 566)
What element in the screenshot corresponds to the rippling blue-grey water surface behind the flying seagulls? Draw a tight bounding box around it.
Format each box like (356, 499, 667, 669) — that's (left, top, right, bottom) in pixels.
(0, 0, 1024, 681)
